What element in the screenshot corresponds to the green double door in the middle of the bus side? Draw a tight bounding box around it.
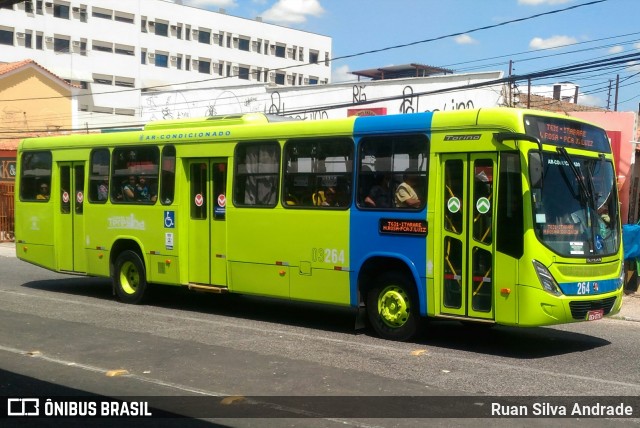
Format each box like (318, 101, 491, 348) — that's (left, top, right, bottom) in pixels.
(185, 159, 227, 287)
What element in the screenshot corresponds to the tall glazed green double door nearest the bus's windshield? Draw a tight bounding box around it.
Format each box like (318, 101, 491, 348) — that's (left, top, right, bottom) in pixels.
(437, 153, 497, 320)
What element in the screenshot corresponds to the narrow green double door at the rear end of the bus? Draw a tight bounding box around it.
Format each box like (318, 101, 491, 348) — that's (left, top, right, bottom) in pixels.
(57, 162, 87, 272)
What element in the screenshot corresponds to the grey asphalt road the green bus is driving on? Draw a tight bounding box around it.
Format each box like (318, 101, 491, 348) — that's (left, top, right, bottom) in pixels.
(0, 252, 640, 427)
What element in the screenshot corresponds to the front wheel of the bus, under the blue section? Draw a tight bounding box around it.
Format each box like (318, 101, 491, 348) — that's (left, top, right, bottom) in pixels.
(367, 272, 420, 341)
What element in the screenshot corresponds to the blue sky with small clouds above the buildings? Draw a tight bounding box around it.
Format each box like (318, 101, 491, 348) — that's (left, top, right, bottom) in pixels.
(182, 0, 640, 111)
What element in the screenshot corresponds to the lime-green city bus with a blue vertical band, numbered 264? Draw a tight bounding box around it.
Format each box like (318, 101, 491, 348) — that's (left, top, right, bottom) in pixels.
(15, 108, 623, 340)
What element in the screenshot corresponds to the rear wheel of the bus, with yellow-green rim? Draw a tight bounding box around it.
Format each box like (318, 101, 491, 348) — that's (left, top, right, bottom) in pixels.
(113, 250, 147, 304)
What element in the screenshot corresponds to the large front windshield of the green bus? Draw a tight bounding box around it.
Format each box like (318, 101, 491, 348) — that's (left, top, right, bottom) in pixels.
(532, 151, 620, 257)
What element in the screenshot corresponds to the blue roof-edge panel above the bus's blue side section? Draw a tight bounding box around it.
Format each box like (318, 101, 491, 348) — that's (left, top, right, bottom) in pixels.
(353, 113, 433, 136)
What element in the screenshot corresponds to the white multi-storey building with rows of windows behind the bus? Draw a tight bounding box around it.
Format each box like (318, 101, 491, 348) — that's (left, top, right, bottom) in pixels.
(0, 0, 331, 128)
